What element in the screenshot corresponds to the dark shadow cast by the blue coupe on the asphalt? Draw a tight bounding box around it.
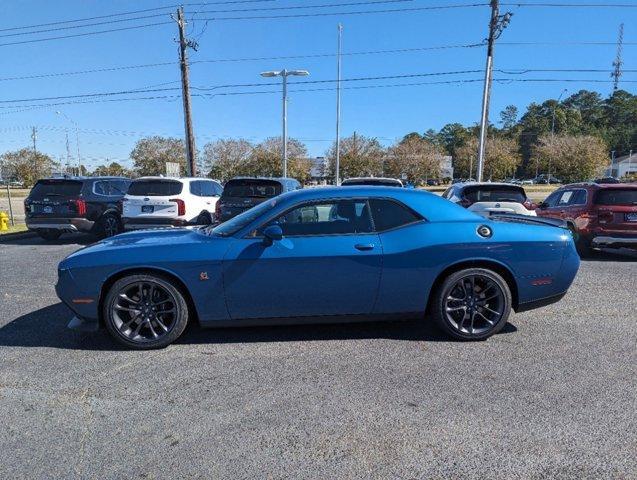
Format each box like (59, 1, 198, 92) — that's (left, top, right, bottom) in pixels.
(0, 303, 517, 351)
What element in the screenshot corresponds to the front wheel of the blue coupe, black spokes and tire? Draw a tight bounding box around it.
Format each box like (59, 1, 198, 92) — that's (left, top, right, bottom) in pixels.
(102, 274, 188, 350)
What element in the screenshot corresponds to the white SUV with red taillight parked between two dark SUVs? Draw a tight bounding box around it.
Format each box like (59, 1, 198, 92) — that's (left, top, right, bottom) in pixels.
(122, 177, 223, 230)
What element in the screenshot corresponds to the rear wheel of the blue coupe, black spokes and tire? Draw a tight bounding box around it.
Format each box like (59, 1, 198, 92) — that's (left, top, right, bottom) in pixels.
(432, 268, 513, 340)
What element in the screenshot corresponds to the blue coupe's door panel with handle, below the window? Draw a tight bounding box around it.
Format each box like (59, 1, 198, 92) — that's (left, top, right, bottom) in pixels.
(222, 234, 382, 319)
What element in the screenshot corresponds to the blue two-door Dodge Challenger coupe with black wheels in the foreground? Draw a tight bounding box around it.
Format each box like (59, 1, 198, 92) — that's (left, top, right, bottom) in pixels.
(56, 187, 579, 349)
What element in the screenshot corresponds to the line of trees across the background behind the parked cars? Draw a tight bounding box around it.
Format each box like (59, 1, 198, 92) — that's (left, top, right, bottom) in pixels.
(0, 90, 637, 186)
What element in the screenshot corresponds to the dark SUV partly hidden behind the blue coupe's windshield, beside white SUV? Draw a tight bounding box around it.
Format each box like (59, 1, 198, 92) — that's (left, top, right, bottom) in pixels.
(216, 177, 303, 222)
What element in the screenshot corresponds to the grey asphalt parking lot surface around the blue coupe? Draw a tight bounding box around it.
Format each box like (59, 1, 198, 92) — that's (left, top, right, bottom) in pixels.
(0, 236, 637, 479)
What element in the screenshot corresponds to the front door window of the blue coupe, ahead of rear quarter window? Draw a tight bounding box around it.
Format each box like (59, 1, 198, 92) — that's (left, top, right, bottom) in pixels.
(270, 200, 372, 236)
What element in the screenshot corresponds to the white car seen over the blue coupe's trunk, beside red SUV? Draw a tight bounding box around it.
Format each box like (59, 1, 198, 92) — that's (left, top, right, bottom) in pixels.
(442, 182, 537, 217)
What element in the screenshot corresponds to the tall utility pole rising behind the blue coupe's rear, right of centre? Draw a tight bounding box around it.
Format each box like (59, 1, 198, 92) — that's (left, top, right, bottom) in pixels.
(477, 0, 513, 182)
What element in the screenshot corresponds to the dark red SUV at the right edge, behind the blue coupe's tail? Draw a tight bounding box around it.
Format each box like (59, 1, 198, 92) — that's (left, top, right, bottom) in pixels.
(536, 183, 637, 254)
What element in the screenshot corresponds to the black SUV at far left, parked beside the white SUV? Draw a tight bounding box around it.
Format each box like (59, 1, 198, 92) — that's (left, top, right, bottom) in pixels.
(24, 177, 131, 240)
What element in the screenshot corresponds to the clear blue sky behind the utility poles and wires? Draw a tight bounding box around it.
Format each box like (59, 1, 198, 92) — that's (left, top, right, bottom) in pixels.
(0, 0, 637, 167)
